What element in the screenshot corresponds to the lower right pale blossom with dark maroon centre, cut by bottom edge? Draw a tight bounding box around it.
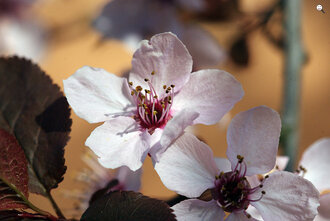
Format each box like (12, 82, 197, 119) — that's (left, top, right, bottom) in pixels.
(155, 106, 319, 221)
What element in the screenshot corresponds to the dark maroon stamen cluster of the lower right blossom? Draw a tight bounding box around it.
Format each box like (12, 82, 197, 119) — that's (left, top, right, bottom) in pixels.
(213, 155, 268, 218)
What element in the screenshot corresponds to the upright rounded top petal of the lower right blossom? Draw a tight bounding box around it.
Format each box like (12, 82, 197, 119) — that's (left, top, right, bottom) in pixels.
(227, 106, 281, 176)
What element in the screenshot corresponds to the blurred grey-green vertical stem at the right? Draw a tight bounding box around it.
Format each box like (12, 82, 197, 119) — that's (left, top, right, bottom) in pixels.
(281, 0, 303, 171)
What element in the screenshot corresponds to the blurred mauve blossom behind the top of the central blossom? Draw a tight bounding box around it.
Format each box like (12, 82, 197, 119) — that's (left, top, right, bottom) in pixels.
(93, 0, 225, 70)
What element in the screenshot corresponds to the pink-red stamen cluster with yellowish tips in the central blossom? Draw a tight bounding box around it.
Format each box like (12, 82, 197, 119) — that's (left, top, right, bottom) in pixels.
(129, 71, 175, 134)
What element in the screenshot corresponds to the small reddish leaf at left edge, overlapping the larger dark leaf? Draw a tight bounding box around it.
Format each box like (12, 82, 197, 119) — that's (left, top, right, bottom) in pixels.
(0, 129, 29, 210)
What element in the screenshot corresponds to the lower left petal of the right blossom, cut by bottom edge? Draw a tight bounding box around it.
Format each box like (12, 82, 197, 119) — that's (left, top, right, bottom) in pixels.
(172, 199, 225, 221)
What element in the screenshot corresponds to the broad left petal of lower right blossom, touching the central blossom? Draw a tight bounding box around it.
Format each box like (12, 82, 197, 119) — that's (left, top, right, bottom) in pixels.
(155, 134, 219, 197)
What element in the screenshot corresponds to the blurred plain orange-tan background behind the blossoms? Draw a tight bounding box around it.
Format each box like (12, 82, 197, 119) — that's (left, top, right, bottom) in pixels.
(10, 0, 330, 217)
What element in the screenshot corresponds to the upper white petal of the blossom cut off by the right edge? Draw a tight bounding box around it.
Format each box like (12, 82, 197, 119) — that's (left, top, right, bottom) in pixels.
(299, 138, 330, 192)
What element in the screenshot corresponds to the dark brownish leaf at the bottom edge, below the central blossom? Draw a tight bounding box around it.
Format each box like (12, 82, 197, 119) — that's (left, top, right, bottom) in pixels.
(81, 191, 176, 221)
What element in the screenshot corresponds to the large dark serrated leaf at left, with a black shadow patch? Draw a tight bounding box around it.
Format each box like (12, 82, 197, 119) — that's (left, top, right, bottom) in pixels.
(0, 57, 72, 195)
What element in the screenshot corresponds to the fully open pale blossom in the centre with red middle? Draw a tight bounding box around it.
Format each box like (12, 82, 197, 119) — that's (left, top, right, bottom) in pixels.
(64, 33, 244, 170)
